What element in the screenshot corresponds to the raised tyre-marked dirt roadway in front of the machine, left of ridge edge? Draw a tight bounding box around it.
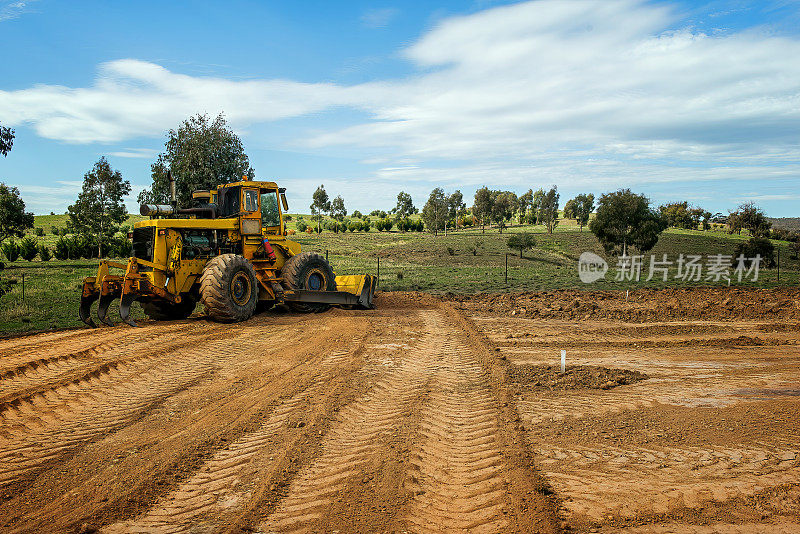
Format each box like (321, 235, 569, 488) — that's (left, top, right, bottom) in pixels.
(0, 297, 558, 532)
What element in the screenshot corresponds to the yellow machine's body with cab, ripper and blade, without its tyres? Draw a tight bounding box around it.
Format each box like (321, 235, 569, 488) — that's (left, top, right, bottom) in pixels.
(80, 180, 376, 326)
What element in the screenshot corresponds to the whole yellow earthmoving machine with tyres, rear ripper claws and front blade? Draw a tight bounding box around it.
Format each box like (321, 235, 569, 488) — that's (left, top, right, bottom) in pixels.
(79, 173, 377, 327)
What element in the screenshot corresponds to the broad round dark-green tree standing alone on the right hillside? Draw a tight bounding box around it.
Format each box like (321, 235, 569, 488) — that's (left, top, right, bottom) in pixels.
(589, 189, 667, 255)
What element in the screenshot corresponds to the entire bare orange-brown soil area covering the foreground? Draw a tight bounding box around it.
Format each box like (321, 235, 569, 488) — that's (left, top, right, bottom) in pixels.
(0, 290, 800, 533)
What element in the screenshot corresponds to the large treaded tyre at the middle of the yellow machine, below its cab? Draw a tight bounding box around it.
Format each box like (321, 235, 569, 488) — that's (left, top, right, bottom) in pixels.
(200, 254, 258, 323)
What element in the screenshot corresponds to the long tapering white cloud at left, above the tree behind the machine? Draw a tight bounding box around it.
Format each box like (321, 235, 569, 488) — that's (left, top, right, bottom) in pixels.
(0, 59, 366, 143)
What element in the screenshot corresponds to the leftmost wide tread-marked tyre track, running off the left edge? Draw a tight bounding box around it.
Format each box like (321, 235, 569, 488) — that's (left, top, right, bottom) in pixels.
(0, 327, 248, 487)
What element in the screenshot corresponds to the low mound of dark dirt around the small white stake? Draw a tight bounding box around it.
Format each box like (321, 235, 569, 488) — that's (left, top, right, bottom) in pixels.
(508, 364, 648, 390)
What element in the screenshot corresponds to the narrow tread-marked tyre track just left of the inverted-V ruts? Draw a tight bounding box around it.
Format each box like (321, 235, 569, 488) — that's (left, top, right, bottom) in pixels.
(103, 346, 364, 533)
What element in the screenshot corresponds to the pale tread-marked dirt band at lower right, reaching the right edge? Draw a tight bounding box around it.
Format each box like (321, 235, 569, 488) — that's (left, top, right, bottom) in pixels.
(535, 444, 800, 521)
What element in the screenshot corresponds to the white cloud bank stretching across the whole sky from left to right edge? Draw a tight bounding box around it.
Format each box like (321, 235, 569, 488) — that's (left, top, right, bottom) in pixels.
(0, 0, 800, 199)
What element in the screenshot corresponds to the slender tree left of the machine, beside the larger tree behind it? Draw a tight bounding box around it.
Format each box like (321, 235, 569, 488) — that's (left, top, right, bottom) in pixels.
(68, 157, 131, 256)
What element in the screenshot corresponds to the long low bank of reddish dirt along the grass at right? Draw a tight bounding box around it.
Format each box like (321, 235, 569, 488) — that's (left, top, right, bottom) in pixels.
(445, 287, 800, 322)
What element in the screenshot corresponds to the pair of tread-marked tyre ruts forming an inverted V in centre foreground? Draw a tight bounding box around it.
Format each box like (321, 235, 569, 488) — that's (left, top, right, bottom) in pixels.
(258, 311, 506, 532)
